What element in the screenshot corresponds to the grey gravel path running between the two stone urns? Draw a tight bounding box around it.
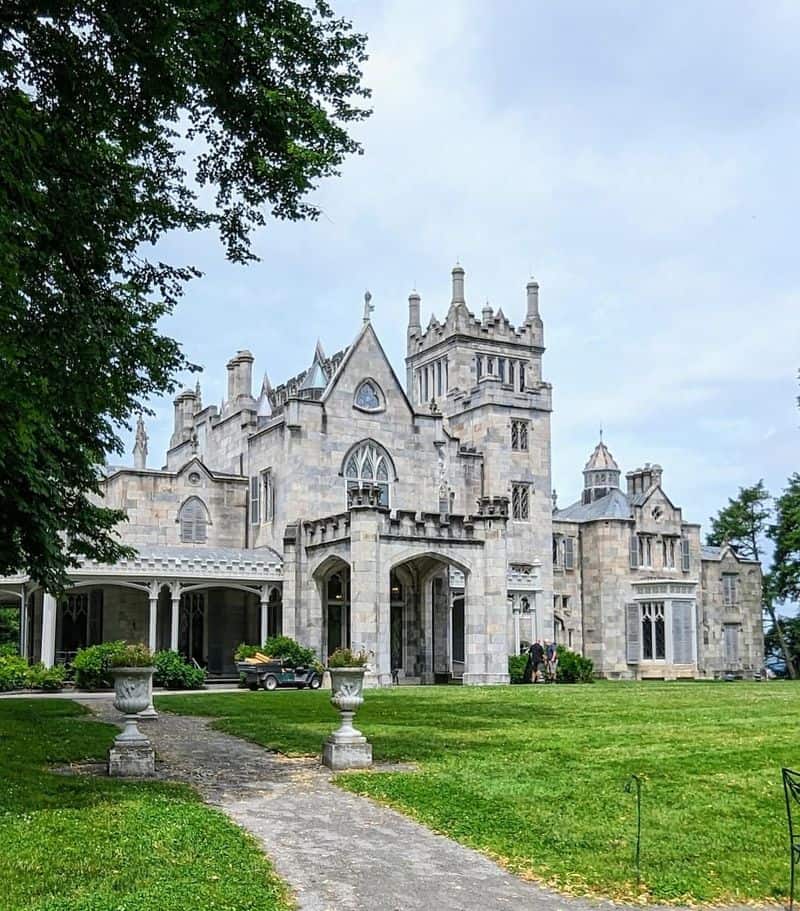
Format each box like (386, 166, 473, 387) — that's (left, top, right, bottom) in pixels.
(78, 699, 756, 911)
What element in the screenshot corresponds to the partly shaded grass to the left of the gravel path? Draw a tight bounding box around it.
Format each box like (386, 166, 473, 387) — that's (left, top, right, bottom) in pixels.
(0, 699, 293, 911)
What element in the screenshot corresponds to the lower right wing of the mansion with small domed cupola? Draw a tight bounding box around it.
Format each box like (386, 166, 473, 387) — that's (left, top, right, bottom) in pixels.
(553, 440, 764, 680)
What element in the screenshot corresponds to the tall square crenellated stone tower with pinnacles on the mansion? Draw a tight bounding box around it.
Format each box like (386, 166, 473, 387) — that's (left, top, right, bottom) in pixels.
(406, 265, 552, 635)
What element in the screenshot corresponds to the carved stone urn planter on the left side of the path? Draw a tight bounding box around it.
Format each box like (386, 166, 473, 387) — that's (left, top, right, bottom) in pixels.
(108, 667, 155, 777)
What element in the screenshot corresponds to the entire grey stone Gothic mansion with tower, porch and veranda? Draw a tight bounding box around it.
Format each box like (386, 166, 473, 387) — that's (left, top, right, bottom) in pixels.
(0, 266, 763, 685)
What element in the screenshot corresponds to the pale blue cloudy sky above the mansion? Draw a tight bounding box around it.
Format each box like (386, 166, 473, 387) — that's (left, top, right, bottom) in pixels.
(127, 0, 800, 540)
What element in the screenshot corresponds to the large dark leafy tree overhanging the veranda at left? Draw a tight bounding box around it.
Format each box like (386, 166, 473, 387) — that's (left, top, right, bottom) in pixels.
(0, 0, 369, 590)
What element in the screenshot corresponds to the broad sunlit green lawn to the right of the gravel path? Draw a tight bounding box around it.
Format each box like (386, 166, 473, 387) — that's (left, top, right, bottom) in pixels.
(158, 682, 800, 903)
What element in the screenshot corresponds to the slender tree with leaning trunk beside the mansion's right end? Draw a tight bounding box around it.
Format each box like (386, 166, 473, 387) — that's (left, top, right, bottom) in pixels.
(706, 480, 796, 677)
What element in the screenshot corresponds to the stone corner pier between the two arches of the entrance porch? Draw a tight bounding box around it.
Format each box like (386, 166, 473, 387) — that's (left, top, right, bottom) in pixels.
(350, 492, 392, 686)
